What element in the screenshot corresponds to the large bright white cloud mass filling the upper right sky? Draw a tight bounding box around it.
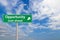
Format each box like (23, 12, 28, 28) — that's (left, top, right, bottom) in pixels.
(30, 0, 60, 30)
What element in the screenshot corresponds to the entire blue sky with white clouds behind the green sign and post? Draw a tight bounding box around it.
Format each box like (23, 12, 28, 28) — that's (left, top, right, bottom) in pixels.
(0, 0, 60, 40)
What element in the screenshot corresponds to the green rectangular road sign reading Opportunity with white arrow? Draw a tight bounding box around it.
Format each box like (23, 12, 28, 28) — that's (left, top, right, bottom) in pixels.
(3, 15, 32, 22)
